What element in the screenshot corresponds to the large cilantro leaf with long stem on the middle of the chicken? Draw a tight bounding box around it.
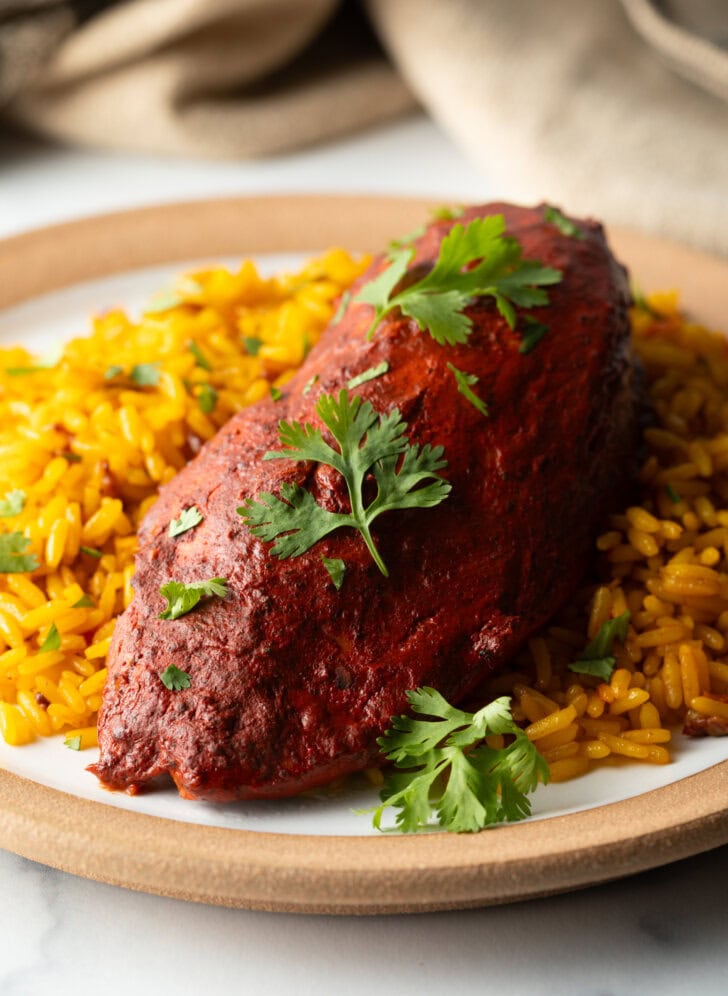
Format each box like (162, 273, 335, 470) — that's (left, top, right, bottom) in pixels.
(238, 390, 450, 577)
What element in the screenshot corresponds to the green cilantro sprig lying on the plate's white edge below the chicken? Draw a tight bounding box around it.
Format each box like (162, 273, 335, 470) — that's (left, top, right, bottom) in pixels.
(373, 687, 549, 833)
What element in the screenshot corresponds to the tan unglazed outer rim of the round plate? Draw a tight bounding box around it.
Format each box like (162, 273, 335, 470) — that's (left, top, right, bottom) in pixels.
(0, 195, 728, 913)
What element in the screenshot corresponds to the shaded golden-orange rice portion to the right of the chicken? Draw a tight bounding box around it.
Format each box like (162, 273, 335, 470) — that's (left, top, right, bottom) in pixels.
(487, 293, 728, 781)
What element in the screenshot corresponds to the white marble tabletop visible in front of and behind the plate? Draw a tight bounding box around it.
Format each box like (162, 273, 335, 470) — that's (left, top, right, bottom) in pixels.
(0, 117, 728, 996)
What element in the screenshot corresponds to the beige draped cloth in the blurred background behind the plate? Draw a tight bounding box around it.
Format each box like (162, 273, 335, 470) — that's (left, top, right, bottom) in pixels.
(0, 0, 728, 254)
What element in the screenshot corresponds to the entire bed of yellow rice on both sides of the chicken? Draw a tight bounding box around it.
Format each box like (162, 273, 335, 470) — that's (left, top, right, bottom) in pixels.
(0, 262, 728, 781)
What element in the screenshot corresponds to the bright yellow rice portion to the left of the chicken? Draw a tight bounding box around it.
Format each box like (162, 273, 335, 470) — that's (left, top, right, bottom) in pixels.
(0, 250, 367, 748)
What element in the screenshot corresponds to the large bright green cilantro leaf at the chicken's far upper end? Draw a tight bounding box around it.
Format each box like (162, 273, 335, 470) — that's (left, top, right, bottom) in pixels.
(355, 215, 561, 345)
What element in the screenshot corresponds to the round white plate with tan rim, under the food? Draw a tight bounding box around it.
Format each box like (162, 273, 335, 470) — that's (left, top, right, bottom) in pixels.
(0, 196, 728, 913)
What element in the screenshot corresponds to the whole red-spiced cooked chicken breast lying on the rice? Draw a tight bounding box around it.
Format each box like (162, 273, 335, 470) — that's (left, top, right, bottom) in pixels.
(93, 204, 638, 801)
